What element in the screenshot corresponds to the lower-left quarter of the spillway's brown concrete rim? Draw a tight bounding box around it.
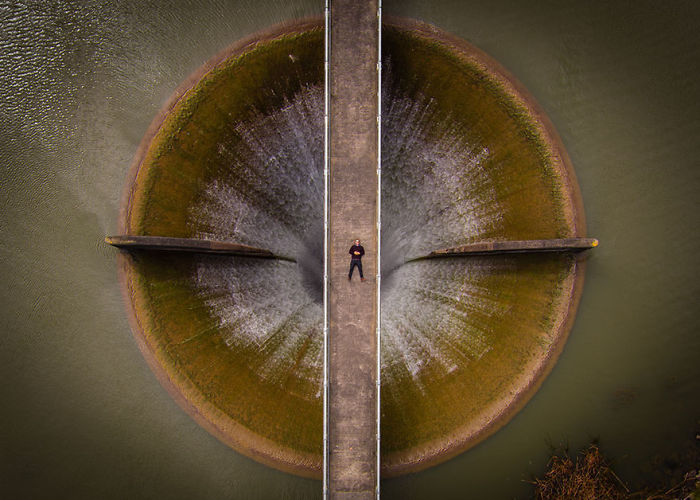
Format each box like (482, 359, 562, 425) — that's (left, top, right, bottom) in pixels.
(117, 252, 322, 479)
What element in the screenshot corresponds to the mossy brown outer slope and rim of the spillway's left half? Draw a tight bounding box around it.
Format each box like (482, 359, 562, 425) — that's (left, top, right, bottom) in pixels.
(121, 20, 323, 477)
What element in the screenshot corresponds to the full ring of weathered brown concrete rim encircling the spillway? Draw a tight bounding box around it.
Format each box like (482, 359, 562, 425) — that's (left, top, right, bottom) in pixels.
(112, 13, 585, 479)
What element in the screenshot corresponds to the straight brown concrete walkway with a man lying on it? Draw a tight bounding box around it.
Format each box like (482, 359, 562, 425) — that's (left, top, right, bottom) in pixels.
(327, 0, 379, 499)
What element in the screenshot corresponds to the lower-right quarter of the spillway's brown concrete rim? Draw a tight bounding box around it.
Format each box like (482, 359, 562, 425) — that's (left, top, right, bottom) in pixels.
(381, 256, 586, 478)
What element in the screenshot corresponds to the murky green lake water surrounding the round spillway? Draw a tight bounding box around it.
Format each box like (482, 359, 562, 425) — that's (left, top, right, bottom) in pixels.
(0, 1, 700, 498)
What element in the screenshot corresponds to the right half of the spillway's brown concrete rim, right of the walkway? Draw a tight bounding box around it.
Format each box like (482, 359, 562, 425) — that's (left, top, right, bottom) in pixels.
(381, 17, 586, 478)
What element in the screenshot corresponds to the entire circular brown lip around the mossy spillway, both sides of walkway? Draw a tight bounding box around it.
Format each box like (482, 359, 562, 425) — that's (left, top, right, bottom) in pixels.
(112, 13, 585, 478)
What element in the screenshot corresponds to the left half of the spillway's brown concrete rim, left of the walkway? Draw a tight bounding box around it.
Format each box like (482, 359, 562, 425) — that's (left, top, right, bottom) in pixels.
(117, 16, 323, 479)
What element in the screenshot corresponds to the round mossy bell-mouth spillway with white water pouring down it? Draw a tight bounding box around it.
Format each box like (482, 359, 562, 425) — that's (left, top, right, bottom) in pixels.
(108, 19, 596, 477)
